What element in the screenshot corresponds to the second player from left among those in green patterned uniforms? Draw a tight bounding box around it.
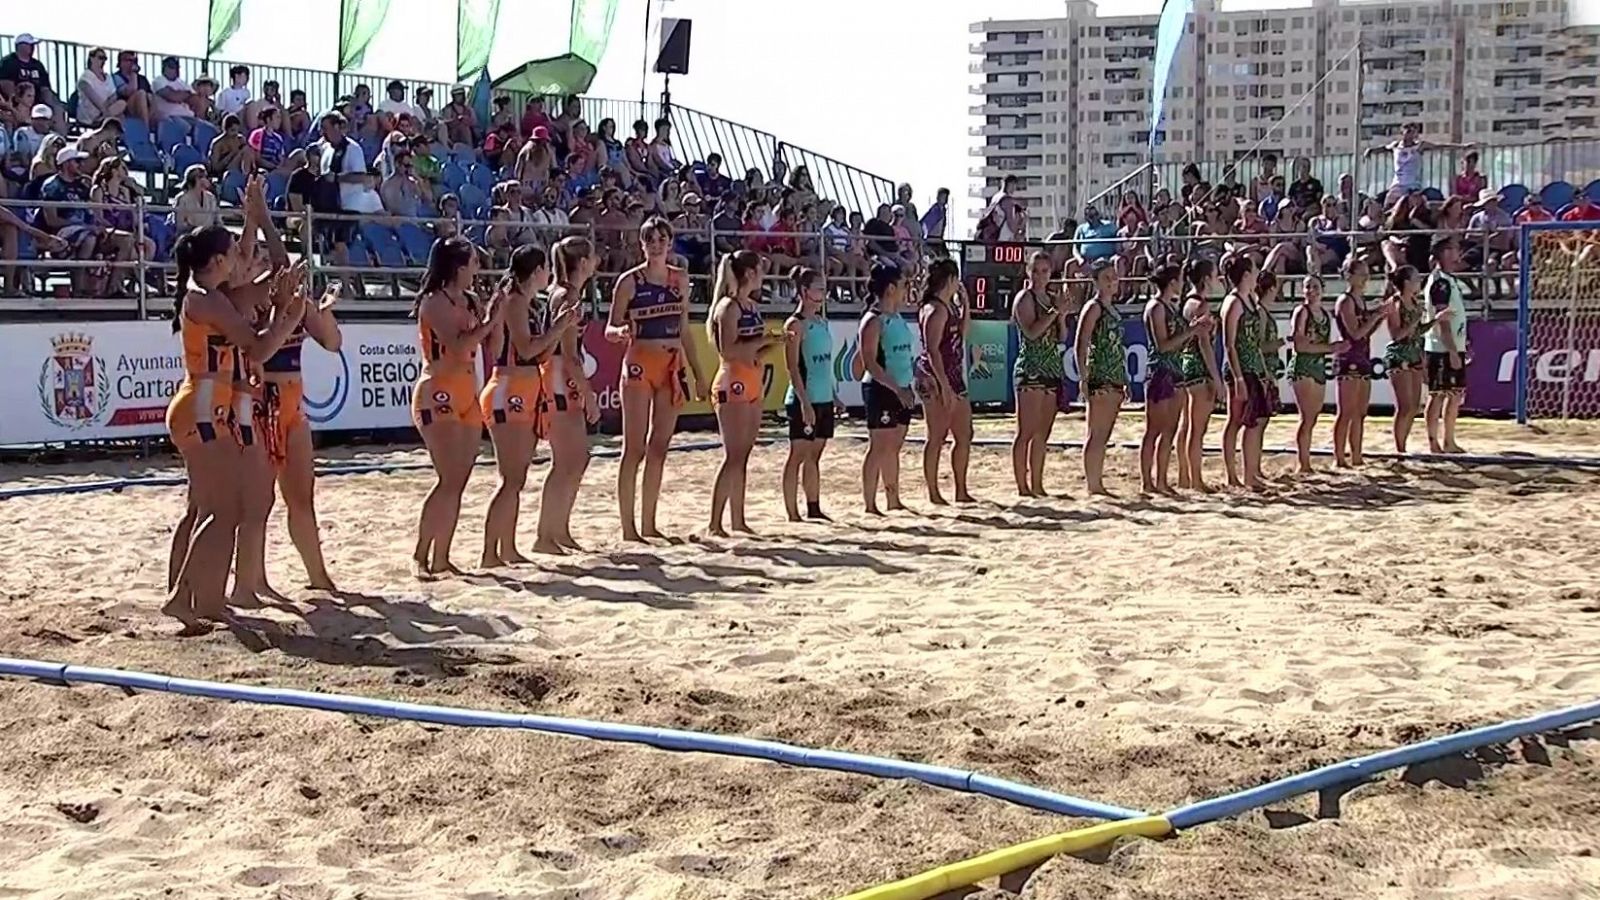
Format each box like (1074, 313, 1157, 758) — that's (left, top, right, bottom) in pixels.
(1074, 259, 1128, 493)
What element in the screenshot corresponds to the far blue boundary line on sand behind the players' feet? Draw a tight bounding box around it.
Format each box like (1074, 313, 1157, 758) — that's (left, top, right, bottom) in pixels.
(0, 434, 1600, 500)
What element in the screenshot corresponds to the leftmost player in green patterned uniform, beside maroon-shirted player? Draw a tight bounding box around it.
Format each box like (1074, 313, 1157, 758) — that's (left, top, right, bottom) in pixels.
(1011, 251, 1072, 496)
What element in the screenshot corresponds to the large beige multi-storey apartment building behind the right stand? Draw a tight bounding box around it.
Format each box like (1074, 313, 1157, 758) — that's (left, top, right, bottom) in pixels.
(968, 0, 1600, 234)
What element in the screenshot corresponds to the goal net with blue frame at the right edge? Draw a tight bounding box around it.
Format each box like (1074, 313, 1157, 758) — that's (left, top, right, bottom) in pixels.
(1517, 223, 1600, 424)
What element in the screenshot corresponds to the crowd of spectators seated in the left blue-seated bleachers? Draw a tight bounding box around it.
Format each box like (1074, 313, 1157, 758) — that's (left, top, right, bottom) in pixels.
(0, 35, 949, 295)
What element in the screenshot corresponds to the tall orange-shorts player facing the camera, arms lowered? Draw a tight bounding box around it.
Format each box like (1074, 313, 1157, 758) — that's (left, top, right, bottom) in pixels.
(605, 218, 707, 541)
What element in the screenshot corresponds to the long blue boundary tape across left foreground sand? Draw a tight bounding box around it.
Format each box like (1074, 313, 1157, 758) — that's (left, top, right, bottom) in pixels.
(0, 657, 1146, 820)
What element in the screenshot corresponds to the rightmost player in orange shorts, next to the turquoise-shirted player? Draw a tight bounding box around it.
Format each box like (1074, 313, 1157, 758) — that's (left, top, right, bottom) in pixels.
(706, 250, 782, 538)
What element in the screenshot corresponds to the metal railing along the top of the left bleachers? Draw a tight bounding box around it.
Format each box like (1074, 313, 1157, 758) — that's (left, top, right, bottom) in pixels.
(0, 35, 894, 219)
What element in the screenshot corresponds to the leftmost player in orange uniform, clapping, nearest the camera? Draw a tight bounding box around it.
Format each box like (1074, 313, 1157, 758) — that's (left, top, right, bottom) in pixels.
(162, 226, 306, 634)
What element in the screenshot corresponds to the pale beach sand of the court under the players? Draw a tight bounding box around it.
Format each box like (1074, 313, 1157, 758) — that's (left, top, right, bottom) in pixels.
(0, 420, 1600, 900)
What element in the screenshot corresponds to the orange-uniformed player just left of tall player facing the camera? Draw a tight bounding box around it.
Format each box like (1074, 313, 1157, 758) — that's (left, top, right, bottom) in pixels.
(533, 237, 600, 554)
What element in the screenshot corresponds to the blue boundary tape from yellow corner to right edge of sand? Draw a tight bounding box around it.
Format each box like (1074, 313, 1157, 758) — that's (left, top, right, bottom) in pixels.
(1166, 700, 1600, 830)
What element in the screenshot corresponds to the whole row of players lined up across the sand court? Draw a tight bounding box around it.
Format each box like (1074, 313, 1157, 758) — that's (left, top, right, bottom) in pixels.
(156, 178, 1466, 634)
